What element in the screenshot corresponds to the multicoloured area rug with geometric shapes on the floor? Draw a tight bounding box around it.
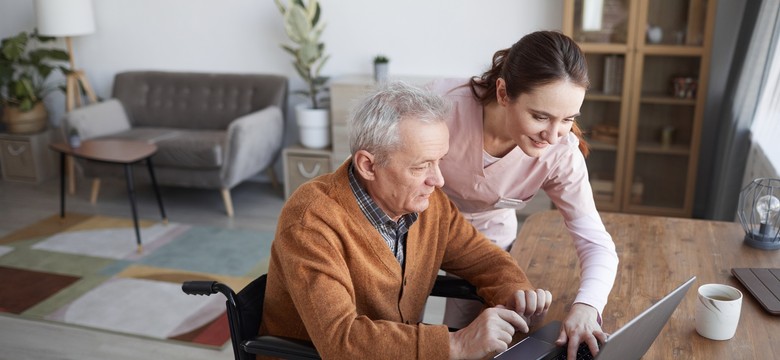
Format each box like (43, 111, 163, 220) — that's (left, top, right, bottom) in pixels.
(0, 214, 273, 348)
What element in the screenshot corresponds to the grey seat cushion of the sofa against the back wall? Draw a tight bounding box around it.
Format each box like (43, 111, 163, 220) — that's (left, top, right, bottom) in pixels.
(95, 127, 227, 169)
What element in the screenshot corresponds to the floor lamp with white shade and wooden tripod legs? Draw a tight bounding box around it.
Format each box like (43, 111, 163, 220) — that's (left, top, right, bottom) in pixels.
(35, 0, 97, 111)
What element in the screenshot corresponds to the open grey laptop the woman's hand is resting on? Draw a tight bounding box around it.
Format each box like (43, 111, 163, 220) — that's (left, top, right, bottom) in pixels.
(494, 276, 696, 360)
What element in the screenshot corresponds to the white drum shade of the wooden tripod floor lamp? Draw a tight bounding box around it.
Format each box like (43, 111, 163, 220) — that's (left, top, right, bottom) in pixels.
(35, 0, 95, 37)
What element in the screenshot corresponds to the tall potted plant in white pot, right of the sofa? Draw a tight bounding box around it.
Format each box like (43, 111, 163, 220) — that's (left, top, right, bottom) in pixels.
(274, 0, 330, 148)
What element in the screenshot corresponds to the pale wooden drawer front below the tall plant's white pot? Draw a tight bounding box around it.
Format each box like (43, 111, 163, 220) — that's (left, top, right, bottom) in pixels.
(283, 149, 331, 198)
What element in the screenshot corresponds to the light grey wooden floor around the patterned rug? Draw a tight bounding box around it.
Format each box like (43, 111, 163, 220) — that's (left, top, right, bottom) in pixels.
(0, 174, 444, 360)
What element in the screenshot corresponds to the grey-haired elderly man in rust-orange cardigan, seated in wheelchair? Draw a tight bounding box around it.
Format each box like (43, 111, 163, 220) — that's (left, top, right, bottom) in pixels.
(260, 83, 552, 359)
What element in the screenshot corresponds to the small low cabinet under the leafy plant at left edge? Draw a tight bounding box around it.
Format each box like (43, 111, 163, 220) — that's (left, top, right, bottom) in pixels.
(0, 130, 54, 183)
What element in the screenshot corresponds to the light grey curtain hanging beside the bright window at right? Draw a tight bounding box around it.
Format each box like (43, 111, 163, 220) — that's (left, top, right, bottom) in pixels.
(700, 0, 780, 221)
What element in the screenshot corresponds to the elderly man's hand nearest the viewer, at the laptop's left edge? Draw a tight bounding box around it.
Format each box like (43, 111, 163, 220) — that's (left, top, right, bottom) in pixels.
(450, 305, 528, 359)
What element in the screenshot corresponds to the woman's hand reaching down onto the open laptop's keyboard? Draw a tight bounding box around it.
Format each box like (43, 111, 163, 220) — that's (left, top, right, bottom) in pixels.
(555, 303, 607, 359)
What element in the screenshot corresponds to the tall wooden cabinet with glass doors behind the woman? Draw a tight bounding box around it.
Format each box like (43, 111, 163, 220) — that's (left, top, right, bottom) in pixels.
(563, 0, 716, 217)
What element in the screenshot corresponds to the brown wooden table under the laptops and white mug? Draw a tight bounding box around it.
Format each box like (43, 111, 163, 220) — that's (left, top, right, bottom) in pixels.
(511, 210, 780, 359)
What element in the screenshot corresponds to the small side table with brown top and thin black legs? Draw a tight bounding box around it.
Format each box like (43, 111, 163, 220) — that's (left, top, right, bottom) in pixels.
(49, 140, 168, 253)
